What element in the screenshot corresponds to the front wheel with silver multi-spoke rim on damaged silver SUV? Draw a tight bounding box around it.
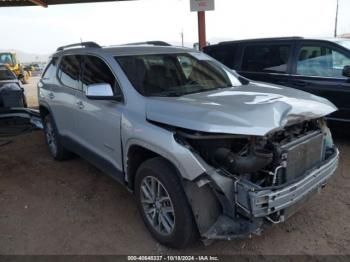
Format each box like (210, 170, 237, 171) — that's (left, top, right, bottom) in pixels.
(135, 157, 197, 248)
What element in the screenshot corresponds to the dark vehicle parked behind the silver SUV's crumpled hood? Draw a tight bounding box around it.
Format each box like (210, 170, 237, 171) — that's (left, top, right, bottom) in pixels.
(203, 37, 350, 125)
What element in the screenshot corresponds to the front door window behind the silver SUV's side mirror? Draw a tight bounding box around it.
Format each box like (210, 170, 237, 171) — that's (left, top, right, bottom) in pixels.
(82, 56, 121, 95)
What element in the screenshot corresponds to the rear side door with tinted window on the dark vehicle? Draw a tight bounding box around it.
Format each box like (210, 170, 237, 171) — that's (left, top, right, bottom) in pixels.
(237, 41, 293, 85)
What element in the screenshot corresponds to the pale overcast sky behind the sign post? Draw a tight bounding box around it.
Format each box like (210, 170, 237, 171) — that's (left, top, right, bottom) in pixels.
(0, 0, 350, 54)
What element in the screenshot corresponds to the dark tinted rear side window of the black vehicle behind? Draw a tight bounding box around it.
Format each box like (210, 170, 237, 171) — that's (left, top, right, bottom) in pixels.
(242, 45, 291, 73)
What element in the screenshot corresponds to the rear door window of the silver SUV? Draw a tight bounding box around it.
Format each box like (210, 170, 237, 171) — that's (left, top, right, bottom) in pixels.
(58, 55, 81, 89)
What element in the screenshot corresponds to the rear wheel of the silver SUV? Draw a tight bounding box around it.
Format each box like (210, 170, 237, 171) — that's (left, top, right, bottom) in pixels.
(43, 115, 71, 161)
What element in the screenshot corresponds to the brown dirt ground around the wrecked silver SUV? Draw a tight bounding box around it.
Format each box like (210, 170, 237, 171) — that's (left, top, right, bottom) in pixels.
(0, 79, 350, 255)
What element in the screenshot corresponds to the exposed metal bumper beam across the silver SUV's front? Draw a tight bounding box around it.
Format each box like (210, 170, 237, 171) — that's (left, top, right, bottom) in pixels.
(234, 149, 339, 218)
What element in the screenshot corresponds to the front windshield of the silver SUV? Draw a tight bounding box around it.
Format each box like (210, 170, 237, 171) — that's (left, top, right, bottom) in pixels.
(115, 52, 241, 96)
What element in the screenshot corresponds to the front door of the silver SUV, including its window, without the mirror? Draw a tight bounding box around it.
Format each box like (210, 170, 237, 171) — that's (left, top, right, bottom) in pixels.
(75, 55, 124, 179)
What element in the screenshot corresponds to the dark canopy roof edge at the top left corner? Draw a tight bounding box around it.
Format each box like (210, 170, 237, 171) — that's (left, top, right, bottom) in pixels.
(0, 0, 130, 7)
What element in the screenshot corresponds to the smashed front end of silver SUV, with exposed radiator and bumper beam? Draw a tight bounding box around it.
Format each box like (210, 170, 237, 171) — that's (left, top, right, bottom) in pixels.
(175, 118, 338, 242)
